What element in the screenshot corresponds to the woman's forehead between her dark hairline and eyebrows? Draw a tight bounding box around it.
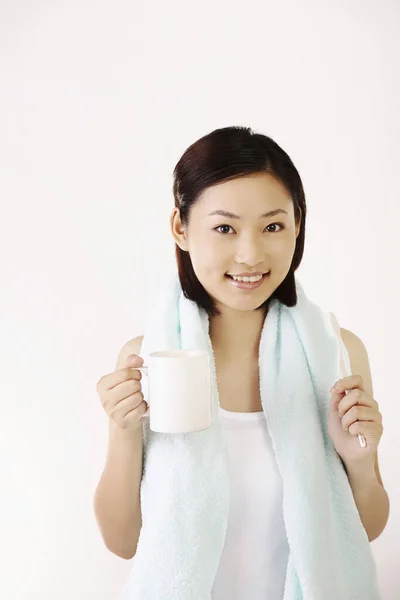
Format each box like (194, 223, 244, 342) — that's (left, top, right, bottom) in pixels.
(196, 173, 292, 212)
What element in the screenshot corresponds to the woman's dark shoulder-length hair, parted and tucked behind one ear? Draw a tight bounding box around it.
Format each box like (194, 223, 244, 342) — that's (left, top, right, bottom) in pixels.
(173, 126, 306, 316)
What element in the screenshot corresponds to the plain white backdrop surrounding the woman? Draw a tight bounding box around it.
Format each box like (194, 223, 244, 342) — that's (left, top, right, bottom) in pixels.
(0, 0, 400, 600)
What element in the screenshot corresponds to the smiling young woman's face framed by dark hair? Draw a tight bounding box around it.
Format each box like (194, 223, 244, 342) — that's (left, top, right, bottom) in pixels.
(171, 173, 299, 311)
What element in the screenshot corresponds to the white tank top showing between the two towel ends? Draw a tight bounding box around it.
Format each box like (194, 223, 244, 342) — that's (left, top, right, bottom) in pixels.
(211, 407, 289, 600)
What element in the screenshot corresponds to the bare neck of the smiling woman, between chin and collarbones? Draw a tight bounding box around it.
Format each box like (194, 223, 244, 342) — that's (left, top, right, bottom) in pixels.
(209, 311, 265, 359)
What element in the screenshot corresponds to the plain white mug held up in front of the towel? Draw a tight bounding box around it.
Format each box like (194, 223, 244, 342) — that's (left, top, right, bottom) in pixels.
(135, 350, 212, 433)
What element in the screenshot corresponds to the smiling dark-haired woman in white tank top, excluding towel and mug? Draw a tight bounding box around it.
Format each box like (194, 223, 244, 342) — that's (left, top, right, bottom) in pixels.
(96, 127, 389, 600)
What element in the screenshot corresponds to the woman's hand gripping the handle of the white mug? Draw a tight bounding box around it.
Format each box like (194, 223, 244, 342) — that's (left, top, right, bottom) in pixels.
(96, 354, 148, 431)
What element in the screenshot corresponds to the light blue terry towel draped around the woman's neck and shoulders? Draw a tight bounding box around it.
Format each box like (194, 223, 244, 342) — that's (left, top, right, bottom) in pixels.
(119, 276, 380, 600)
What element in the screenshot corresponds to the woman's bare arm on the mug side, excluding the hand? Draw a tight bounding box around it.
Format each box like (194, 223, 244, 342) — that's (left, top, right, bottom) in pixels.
(94, 337, 143, 559)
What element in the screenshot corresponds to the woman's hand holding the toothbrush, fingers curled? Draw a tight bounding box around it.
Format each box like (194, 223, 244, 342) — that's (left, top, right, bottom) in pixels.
(328, 375, 383, 464)
